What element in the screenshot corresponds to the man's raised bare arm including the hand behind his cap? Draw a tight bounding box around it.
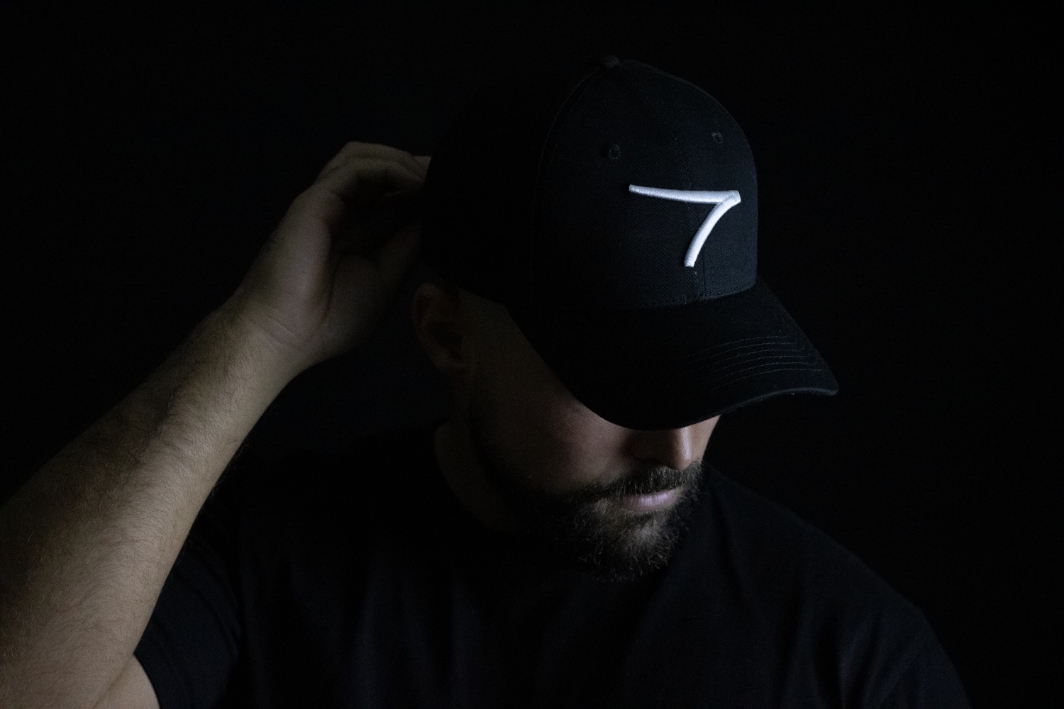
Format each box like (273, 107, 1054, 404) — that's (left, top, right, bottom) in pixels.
(0, 143, 428, 709)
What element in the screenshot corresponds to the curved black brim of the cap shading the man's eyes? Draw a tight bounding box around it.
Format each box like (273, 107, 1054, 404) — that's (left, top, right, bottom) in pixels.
(508, 276, 838, 430)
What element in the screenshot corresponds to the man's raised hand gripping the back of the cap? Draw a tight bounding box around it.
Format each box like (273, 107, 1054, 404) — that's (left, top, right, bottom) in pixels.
(227, 143, 430, 374)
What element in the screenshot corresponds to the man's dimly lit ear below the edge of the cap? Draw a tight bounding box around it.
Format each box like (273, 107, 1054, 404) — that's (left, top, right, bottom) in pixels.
(411, 281, 469, 379)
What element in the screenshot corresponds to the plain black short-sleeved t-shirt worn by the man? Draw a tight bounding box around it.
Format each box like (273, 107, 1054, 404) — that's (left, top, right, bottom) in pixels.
(136, 421, 968, 709)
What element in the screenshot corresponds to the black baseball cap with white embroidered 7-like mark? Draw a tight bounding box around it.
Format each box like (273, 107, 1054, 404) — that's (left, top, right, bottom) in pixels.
(421, 55, 838, 430)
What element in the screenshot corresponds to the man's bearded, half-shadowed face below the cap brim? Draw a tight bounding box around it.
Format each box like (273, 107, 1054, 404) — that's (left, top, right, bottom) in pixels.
(460, 289, 718, 578)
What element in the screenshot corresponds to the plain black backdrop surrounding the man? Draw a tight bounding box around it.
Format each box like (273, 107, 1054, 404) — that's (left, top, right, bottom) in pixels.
(0, 2, 1064, 707)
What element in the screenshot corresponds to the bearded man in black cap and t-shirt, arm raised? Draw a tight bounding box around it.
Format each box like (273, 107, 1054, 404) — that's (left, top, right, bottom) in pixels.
(0, 56, 966, 707)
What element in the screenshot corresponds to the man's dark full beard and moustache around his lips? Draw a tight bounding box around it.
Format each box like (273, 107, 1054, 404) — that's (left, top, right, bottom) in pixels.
(468, 387, 702, 580)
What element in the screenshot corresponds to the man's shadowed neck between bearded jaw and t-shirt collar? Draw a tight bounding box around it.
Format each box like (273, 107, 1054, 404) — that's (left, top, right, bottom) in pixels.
(433, 413, 518, 532)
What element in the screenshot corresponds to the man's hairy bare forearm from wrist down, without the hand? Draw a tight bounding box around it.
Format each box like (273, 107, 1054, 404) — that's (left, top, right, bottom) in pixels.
(0, 300, 296, 707)
